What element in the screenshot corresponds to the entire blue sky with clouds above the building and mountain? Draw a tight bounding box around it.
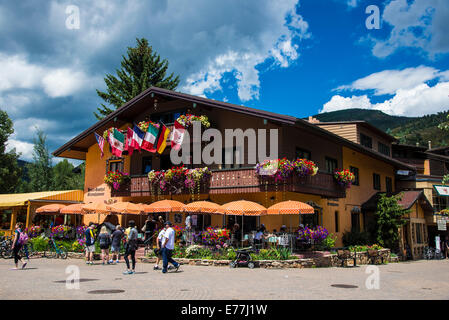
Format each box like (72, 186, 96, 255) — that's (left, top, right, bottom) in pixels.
(0, 0, 449, 160)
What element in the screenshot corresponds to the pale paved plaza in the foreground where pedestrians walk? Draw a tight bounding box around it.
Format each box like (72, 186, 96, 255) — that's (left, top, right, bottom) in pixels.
(0, 259, 449, 300)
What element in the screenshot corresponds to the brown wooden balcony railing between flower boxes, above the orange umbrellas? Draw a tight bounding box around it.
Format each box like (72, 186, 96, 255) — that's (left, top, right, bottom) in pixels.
(112, 168, 346, 198)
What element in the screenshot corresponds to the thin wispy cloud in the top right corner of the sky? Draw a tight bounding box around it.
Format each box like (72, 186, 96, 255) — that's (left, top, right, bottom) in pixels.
(370, 0, 449, 58)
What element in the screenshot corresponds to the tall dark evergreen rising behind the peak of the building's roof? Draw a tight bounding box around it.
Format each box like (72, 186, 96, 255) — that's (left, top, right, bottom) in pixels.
(94, 38, 179, 120)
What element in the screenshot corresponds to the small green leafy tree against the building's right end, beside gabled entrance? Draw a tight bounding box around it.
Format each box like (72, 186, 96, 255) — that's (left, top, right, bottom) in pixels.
(375, 193, 410, 249)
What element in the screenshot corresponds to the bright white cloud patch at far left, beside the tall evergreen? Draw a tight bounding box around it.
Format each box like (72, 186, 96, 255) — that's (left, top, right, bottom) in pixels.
(0, 53, 93, 97)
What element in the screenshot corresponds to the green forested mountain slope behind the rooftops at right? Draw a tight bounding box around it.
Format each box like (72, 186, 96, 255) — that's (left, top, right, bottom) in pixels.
(314, 109, 449, 147)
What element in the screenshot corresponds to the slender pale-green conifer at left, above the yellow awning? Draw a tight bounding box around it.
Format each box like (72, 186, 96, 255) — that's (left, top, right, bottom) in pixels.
(28, 129, 53, 192)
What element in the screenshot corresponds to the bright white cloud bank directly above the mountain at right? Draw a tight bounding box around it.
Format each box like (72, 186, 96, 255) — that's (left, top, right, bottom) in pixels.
(320, 66, 449, 116)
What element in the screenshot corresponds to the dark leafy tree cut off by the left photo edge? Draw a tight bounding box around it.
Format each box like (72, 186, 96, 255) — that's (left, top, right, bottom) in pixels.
(0, 109, 22, 193)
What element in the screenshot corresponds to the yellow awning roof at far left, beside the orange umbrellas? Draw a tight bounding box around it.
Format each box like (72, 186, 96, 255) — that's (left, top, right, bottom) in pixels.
(0, 190, 84, 207)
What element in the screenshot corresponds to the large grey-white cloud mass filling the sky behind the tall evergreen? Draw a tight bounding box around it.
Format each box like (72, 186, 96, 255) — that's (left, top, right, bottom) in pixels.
(0, 0, 310, 160)
